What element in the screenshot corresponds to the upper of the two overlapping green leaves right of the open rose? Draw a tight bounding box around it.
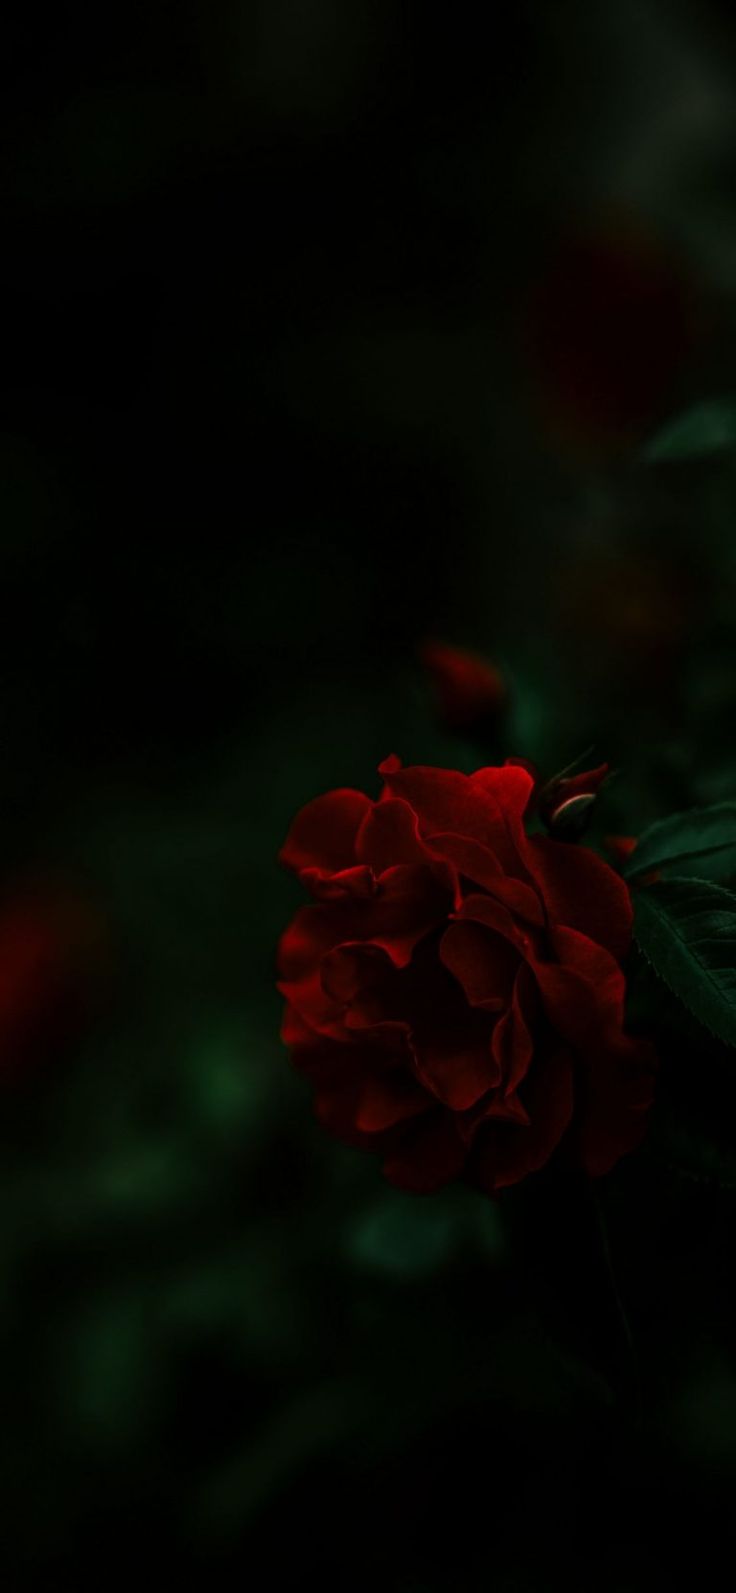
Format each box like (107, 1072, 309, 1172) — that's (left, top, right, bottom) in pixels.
(624, 801, 736, 881)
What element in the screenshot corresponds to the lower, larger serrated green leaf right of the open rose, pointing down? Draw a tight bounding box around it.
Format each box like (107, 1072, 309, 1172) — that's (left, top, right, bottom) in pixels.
(634, 879, 736, 1045)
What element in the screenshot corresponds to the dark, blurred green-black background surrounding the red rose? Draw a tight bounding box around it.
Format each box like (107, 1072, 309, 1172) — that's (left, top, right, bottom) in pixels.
(0, 0, 736, 1593)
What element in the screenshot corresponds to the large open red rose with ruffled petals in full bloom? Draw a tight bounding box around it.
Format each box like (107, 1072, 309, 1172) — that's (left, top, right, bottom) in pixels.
(279, 758, 653, 1192)
